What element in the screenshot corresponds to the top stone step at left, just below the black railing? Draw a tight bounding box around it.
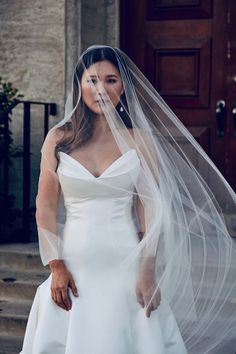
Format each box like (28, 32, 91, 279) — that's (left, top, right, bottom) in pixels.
(0, 243, 48, 272)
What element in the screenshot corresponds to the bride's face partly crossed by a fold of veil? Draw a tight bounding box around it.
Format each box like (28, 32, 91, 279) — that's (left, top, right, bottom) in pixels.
(81, 60, 123, 114)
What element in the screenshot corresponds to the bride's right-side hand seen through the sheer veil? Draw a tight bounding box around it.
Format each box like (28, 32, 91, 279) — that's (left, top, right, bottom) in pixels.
(136, 266, 161, 318)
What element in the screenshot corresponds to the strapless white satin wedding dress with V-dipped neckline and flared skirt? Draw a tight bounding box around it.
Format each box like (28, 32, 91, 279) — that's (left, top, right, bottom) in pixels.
(21, 149, 187, 354)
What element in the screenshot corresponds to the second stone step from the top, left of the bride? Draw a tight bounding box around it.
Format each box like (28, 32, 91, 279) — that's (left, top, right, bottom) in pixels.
(0, 268, 49, 301)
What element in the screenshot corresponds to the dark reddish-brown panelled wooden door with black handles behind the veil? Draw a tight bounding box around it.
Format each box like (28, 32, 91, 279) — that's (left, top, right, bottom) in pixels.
(120, 0, 236, 190)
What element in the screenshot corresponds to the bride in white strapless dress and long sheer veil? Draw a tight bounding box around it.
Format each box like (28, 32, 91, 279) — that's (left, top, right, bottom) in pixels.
(21, 46, 236, 354)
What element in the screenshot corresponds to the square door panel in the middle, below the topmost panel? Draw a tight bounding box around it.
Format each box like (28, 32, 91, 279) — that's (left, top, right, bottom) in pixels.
(145, 35, 211, 108)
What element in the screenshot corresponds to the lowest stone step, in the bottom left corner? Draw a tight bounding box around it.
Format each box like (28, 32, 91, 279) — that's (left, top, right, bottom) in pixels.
(0, 333, 23, 354)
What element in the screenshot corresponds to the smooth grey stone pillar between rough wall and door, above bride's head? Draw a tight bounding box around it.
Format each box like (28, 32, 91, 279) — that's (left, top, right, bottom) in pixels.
(65, 0, 119, 92)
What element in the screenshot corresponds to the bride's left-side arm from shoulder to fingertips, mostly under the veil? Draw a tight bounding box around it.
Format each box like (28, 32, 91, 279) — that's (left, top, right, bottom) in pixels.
(36, 130, 78, 310)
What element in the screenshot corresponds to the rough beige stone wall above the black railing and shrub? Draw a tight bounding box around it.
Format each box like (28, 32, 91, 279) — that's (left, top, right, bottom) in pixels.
(0, 0, 65, 107)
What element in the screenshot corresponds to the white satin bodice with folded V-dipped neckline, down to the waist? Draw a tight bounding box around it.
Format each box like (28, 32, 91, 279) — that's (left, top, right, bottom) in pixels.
(57, 149, 140, 225)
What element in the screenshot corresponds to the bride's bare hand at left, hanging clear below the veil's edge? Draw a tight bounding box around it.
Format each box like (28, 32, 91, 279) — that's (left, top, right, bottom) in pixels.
(49, 260, 79, 311)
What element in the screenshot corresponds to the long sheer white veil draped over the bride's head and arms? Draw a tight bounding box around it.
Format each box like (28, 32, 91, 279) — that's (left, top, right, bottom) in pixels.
(37, 45, 236, 354)
